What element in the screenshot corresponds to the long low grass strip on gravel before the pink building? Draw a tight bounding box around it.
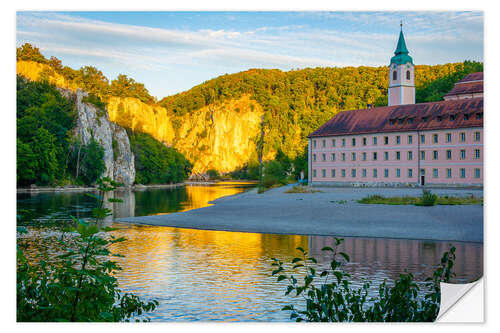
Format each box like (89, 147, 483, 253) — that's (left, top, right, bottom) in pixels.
(358, 192, 483, 206)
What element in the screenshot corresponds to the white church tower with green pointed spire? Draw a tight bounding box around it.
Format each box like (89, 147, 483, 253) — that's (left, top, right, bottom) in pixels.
(388, 23, 415, 106)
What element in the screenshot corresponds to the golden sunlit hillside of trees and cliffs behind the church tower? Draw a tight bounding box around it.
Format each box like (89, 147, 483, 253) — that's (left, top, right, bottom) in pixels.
(17, 45, 483, 173)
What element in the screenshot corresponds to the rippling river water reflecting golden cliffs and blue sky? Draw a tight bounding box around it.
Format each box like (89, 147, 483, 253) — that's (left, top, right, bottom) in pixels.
(17, 182, 483, 321)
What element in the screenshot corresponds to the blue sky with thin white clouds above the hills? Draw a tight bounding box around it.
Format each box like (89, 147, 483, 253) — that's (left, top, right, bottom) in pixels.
(16, 11, 483, 99)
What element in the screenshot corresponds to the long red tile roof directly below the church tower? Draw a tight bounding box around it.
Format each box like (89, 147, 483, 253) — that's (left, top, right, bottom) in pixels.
(308, 97, 483, 138)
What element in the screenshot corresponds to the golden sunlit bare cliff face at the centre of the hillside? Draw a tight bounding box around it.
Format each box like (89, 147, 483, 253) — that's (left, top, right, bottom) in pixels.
(107, 92, 263, 174)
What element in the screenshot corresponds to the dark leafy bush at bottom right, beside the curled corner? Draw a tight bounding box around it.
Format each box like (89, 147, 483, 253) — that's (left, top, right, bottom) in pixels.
(272, 238, 455, 322)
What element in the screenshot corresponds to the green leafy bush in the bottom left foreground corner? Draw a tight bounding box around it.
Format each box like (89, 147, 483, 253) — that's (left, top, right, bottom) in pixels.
(17, 178, 158, 322)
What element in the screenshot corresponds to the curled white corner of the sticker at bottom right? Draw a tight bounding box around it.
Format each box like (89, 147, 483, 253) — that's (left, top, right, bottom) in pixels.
(436, 278, 484, 323)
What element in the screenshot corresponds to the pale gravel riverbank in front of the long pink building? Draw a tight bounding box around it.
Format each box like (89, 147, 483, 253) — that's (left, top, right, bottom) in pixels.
(116, 186, 483, 242)
